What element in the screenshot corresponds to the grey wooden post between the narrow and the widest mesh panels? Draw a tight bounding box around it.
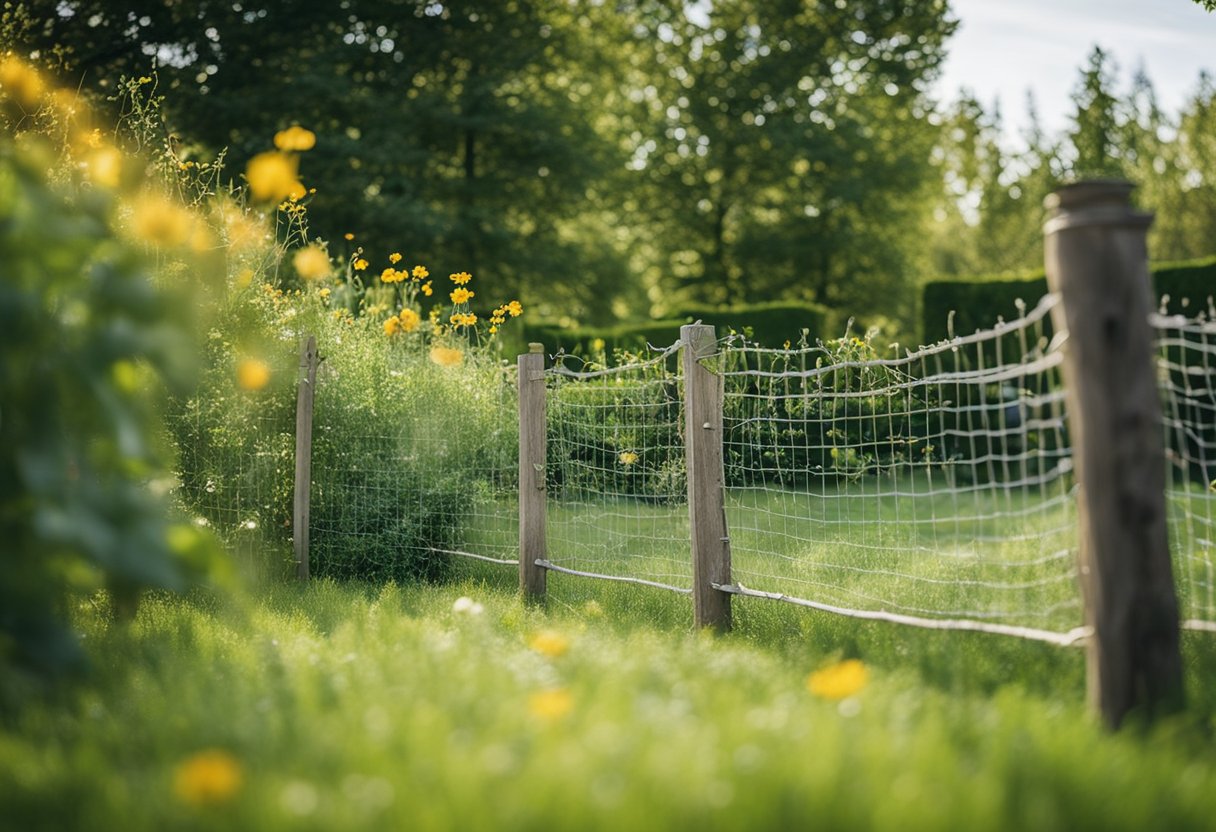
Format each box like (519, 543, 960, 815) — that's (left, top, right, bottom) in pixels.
(680, 324, 731, 631)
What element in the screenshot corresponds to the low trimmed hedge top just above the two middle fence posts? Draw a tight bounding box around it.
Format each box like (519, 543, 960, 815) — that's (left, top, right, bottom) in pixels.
(523, 302, 839, 355)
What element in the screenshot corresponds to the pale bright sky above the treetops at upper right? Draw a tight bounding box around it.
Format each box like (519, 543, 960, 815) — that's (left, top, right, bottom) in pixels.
(936, 0, 1216, 141)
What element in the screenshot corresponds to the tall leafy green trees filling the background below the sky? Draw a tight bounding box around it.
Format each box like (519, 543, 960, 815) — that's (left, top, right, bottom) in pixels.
(2, 0, 1216, 338)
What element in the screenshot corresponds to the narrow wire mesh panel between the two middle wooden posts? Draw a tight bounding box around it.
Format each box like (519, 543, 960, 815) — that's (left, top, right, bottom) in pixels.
(546, 344, 692, 591)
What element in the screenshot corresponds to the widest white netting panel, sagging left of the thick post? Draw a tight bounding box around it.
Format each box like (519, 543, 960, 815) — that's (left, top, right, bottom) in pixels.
(715, 295, 1082, 635)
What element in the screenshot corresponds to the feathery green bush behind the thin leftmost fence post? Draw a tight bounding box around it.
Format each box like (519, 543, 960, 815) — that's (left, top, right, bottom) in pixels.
(174, 286, 518, 580)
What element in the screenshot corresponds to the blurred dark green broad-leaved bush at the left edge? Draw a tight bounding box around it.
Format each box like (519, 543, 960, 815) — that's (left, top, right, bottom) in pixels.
(0, 123, 218, 673)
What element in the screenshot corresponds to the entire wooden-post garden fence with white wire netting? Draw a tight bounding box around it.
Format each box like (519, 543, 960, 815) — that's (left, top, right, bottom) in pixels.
(235, 184, 1216, 724)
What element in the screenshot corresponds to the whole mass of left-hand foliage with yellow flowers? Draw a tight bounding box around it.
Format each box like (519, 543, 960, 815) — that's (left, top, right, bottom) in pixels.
(0, 56, 523, 678)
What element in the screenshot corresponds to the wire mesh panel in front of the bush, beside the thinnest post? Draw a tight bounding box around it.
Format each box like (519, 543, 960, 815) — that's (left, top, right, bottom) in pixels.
(310, 361, 519, 580)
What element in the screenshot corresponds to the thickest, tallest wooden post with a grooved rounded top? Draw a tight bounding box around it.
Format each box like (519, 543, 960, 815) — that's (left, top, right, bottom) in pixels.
(1045, 181, 1182, 727)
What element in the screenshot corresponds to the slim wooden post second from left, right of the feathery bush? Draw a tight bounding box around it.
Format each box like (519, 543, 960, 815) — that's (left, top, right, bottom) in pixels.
(519, 343, 546, 601)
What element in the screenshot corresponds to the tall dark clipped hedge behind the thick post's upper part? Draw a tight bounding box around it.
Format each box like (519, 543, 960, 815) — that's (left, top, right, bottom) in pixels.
(921, 257, 1216, 343)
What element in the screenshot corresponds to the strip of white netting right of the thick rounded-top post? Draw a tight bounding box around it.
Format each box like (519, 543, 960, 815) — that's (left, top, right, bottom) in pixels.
(1152, 310, 1216, 629)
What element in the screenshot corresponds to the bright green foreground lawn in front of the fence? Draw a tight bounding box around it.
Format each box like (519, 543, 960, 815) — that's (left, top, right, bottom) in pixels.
(0, 571, 1216, 831)
